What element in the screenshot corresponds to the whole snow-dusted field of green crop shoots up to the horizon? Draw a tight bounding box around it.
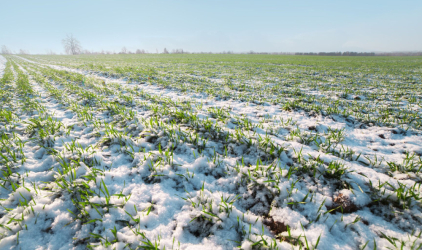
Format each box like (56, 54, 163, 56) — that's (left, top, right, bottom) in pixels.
(0, 55, 422, 249)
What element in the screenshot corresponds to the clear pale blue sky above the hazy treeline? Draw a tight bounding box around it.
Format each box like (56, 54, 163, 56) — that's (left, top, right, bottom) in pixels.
(0, 0, 422, 53)
